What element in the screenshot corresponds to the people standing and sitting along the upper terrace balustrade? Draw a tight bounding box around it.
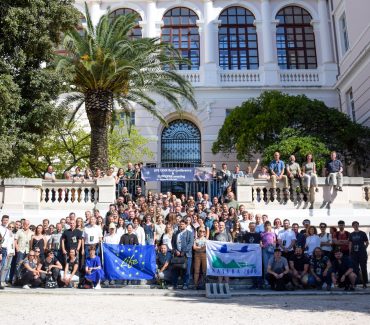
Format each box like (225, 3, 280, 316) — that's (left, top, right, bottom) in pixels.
(44, 151, 343, 203)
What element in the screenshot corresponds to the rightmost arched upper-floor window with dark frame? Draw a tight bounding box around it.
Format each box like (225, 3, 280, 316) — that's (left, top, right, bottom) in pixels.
(276, 6, 316, 69)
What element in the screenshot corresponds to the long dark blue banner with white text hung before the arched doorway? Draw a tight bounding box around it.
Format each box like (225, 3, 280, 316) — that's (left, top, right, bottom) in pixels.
(141, 167, 212, 182)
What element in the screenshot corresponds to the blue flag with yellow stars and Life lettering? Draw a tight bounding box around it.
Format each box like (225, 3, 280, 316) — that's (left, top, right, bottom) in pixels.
(103, 243, 156, 281)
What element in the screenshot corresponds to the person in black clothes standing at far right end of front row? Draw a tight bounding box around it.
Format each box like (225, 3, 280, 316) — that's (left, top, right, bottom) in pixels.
(349, 221, 369, 289)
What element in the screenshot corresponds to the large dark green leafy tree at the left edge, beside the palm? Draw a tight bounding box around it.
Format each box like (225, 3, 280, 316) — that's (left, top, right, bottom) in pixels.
(0, 0, 79, 177)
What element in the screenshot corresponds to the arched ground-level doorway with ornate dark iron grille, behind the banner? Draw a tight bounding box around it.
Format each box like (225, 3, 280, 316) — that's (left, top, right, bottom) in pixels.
(161, 120, 202, 195)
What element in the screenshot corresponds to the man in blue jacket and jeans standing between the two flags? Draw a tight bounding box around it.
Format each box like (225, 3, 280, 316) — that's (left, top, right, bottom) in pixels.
(172, 220, 194, 290)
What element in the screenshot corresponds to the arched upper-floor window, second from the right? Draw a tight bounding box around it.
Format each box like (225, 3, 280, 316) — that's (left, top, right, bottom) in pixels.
(218, 7, 258, 70)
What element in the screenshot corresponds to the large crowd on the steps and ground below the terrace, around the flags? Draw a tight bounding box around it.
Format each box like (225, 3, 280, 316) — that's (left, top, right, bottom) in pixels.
(0, 181, 369, 290)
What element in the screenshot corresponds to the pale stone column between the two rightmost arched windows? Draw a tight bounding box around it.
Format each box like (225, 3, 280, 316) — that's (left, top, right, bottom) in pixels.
(255, 0, 279, 86)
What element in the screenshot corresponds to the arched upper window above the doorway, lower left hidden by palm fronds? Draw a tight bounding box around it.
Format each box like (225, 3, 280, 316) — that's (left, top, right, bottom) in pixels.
(161, 7, 200, 70)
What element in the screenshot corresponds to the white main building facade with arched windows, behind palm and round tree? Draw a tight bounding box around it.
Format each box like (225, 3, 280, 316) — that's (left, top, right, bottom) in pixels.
(76, 0, 346, 168)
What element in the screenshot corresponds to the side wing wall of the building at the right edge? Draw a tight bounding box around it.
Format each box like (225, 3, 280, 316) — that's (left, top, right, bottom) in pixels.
(331, 0, 370, 127)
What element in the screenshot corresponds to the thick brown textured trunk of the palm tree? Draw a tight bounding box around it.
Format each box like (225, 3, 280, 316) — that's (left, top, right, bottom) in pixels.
(85, 90, 113, 171)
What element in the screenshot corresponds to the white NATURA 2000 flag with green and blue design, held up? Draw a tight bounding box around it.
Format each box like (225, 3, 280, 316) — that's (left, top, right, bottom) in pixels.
(206, 240, 262, 278)
